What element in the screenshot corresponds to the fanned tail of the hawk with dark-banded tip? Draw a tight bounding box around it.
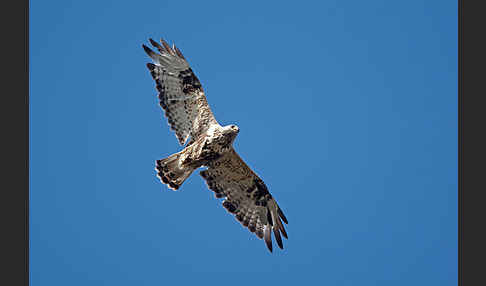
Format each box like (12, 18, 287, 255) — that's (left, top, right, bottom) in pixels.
(155, 153, 194, 191)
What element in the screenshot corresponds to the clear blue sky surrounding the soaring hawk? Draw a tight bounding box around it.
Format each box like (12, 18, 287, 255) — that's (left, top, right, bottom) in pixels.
(31, 0, 457, 286)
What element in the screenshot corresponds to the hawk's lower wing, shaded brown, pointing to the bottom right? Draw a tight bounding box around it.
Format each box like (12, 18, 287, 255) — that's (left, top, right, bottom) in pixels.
(200, 149, 288, 252)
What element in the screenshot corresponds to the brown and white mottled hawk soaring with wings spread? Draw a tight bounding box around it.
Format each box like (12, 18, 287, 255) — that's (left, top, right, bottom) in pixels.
(142, 39, 288, 252)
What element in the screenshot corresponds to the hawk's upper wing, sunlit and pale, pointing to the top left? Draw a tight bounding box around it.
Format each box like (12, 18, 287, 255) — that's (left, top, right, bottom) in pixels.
(142, 39, 216, 145)
